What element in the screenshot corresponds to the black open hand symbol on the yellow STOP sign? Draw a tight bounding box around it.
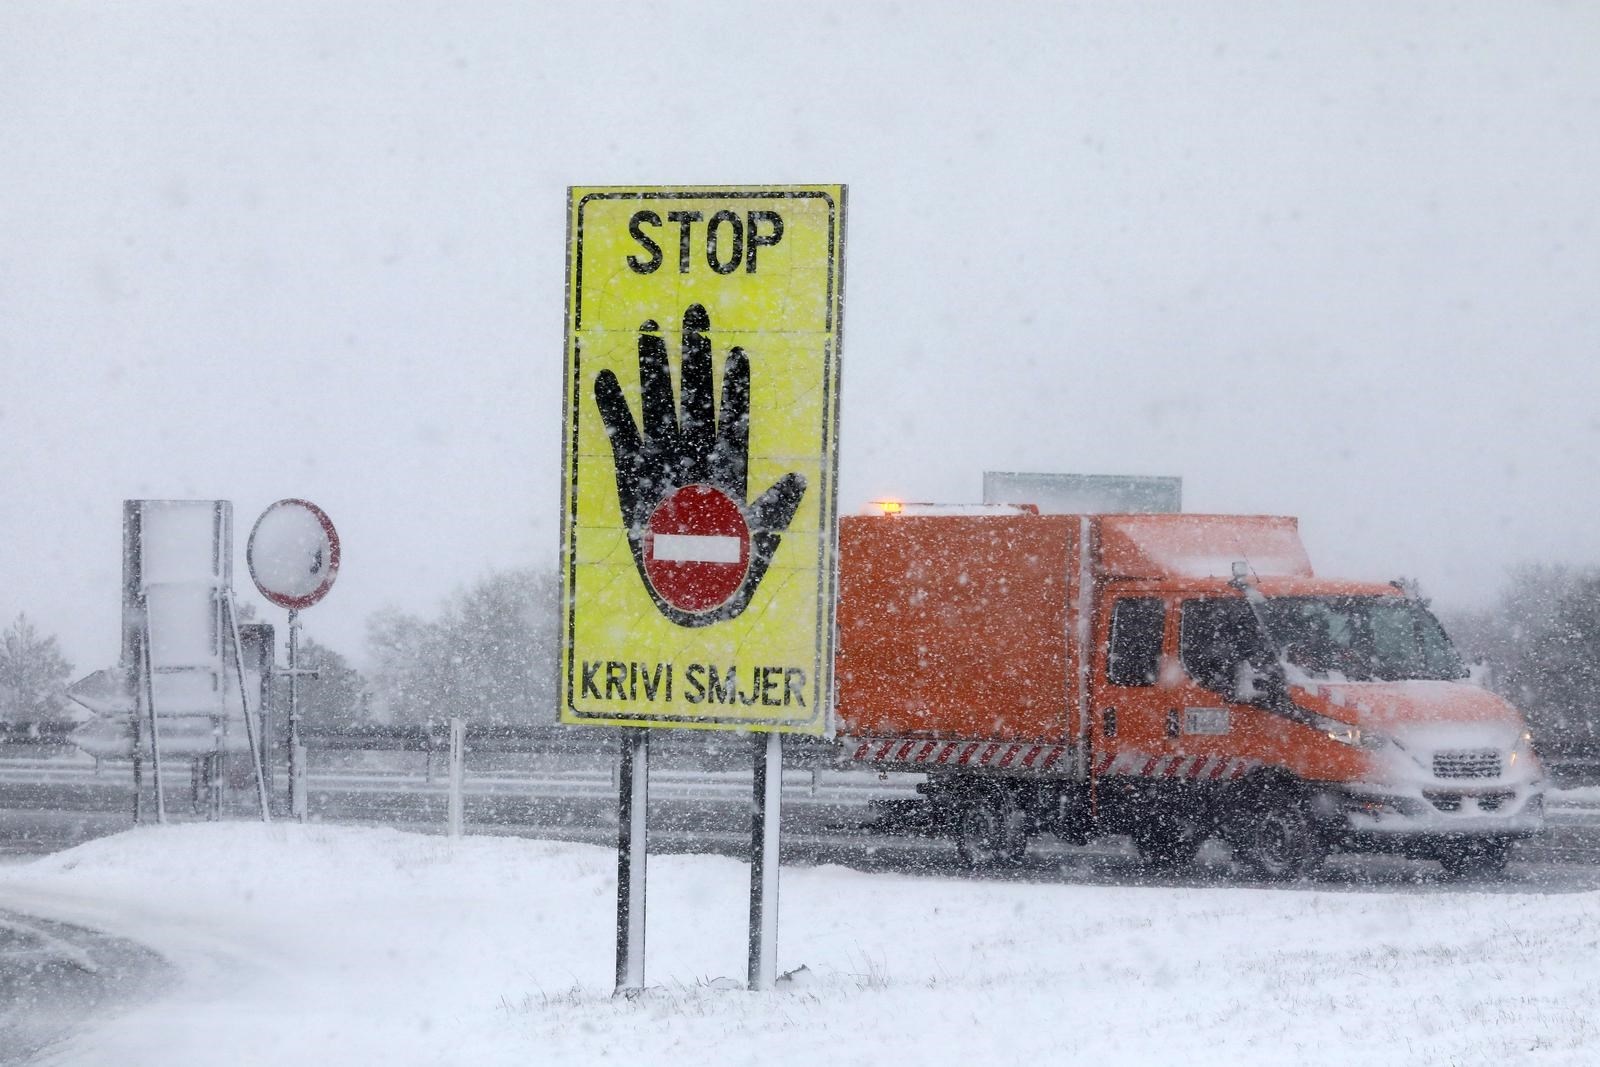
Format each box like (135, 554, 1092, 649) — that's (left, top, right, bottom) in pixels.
(595, 304, 805, 625)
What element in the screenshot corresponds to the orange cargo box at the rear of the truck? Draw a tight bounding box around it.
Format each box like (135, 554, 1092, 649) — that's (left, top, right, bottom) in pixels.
(835, 515, 1082, 744)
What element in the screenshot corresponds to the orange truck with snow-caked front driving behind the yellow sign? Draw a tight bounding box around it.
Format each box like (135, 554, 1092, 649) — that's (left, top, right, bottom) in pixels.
(835, 506, 1544, 880)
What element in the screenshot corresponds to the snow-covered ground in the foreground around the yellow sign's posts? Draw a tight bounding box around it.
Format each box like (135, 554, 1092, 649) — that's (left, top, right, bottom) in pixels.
(0, 824, 1600, 1067)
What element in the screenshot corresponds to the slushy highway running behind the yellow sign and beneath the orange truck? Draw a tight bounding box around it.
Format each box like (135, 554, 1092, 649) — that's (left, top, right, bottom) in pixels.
(9, 760, 1600, 891)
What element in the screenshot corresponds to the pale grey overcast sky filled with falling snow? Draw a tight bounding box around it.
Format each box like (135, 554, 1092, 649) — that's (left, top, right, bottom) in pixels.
(0, 0, 1600, 672)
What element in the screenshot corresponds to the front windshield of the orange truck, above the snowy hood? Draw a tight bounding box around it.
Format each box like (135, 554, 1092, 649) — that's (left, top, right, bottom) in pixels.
(1266, 597, 1467, 681)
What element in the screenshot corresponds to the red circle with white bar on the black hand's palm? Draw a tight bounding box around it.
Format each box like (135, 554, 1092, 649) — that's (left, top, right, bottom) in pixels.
(645, 483, 750, 614)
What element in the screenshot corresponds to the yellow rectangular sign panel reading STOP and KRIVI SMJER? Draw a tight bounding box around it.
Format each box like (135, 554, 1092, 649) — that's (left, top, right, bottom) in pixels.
(560, 186, 845, 733)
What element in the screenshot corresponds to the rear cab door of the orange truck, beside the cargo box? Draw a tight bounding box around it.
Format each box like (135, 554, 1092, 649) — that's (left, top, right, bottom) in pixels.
(1091, 592, 1170, 776)
